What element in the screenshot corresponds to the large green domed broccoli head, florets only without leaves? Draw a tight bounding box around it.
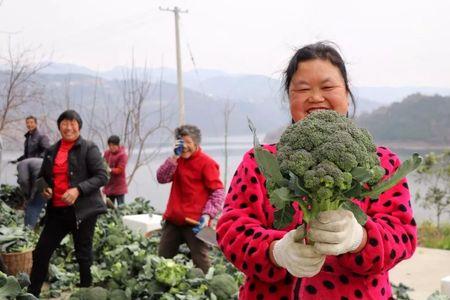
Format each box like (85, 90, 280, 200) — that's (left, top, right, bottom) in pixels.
(277, 110, 384, 200)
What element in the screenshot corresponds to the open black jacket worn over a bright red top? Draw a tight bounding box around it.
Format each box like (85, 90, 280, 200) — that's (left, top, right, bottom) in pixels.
(39, 136, 109, 225)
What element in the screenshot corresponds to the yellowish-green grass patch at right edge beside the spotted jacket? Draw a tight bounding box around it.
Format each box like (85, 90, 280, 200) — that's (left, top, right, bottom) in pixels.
(418, 221, 450, 250)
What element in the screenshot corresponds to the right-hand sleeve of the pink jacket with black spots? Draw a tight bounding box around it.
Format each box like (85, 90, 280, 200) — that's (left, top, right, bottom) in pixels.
(338, 147, 417, 275)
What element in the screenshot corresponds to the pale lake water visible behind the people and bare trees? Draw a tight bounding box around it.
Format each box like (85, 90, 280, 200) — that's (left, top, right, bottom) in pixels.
(0, 136, 442, 222)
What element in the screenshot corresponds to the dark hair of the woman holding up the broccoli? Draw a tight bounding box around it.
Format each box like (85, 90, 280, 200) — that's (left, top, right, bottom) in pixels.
(283, 42, 356, 115)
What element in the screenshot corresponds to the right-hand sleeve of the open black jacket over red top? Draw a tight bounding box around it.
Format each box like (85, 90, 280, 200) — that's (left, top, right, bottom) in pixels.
(76, 143, 109, 195)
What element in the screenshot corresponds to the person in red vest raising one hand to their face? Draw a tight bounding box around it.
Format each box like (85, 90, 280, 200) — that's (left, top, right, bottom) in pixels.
(157, 125, 224, 273)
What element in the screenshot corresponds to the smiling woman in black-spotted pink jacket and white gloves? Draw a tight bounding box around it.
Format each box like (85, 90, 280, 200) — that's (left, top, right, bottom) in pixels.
(217, 43, 416, 300)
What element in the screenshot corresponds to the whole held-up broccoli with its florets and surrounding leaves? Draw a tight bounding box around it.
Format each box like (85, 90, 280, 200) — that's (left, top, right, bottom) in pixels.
(249, 110, 422, 228)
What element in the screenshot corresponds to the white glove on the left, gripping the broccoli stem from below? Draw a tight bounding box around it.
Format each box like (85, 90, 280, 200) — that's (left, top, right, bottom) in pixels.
(273, 229, 325, 277)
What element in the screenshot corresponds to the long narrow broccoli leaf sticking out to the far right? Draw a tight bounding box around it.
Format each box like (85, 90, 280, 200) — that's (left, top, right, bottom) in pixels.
(361, 153, 423, 198)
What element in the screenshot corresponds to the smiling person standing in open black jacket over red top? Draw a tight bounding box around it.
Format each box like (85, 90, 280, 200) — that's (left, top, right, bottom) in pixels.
(28, 110, 109, 297)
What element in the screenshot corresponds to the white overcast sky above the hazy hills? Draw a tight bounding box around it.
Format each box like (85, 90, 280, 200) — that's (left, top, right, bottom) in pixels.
(0, 0, 450, 87)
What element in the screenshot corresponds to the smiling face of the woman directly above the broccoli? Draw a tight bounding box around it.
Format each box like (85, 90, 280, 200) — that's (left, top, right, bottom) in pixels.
(289, 59, 349, 122)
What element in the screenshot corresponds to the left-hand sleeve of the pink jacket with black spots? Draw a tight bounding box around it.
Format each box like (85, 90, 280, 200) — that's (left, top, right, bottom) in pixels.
(217, 151, 287, 283)
